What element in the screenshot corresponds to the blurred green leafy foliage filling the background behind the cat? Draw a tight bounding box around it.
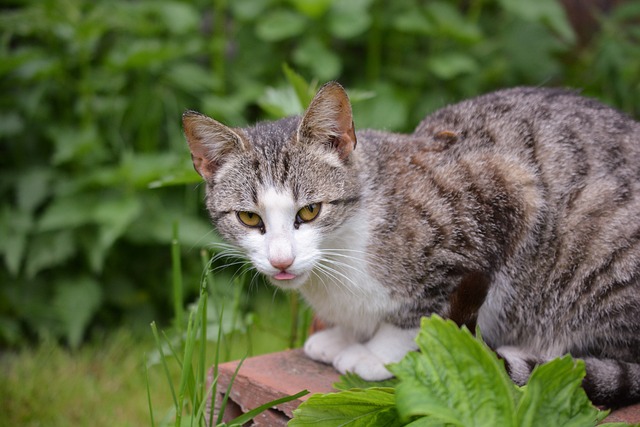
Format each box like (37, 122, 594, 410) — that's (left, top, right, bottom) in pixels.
(0, 0, 640, 347)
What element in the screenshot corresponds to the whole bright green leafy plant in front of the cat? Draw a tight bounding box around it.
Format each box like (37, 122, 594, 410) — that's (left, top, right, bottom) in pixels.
(289, 315, 632, 427)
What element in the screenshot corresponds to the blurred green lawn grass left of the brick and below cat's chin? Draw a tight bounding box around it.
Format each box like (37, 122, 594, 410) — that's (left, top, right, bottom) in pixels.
(0, 290, 304, 427)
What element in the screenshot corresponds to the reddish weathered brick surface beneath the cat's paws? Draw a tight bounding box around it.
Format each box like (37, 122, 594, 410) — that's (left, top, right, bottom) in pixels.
(207, 350, 640, 427)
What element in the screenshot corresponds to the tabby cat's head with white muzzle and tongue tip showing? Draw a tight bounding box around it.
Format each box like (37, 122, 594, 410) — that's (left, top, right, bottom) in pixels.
(183, 83, 360, 288)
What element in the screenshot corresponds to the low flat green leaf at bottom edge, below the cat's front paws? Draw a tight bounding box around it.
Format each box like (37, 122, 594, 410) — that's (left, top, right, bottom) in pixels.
(289, 388, 402, 427)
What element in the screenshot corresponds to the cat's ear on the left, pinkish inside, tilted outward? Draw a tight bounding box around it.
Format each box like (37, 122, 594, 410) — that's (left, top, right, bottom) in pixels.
(182, 111, 247, 179)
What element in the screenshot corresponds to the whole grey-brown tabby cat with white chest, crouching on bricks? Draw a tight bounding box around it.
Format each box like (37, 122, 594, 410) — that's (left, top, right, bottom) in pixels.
(183, 83, 640, 406)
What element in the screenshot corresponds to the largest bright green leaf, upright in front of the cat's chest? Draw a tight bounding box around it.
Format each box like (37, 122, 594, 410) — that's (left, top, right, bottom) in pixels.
(389, 316, 516, 427)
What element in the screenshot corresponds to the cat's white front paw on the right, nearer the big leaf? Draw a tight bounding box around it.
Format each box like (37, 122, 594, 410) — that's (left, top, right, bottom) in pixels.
(333, 323, 418, 381)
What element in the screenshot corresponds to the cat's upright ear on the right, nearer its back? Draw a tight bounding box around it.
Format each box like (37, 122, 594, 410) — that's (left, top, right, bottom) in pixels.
(298, 82, 357, 160)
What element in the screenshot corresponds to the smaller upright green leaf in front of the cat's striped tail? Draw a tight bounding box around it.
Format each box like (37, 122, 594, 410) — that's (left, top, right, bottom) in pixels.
(517, 356, 601, 427)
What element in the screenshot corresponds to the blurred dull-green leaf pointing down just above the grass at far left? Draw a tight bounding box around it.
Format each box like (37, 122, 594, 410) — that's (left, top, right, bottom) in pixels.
(53, 277, 102, 348)
